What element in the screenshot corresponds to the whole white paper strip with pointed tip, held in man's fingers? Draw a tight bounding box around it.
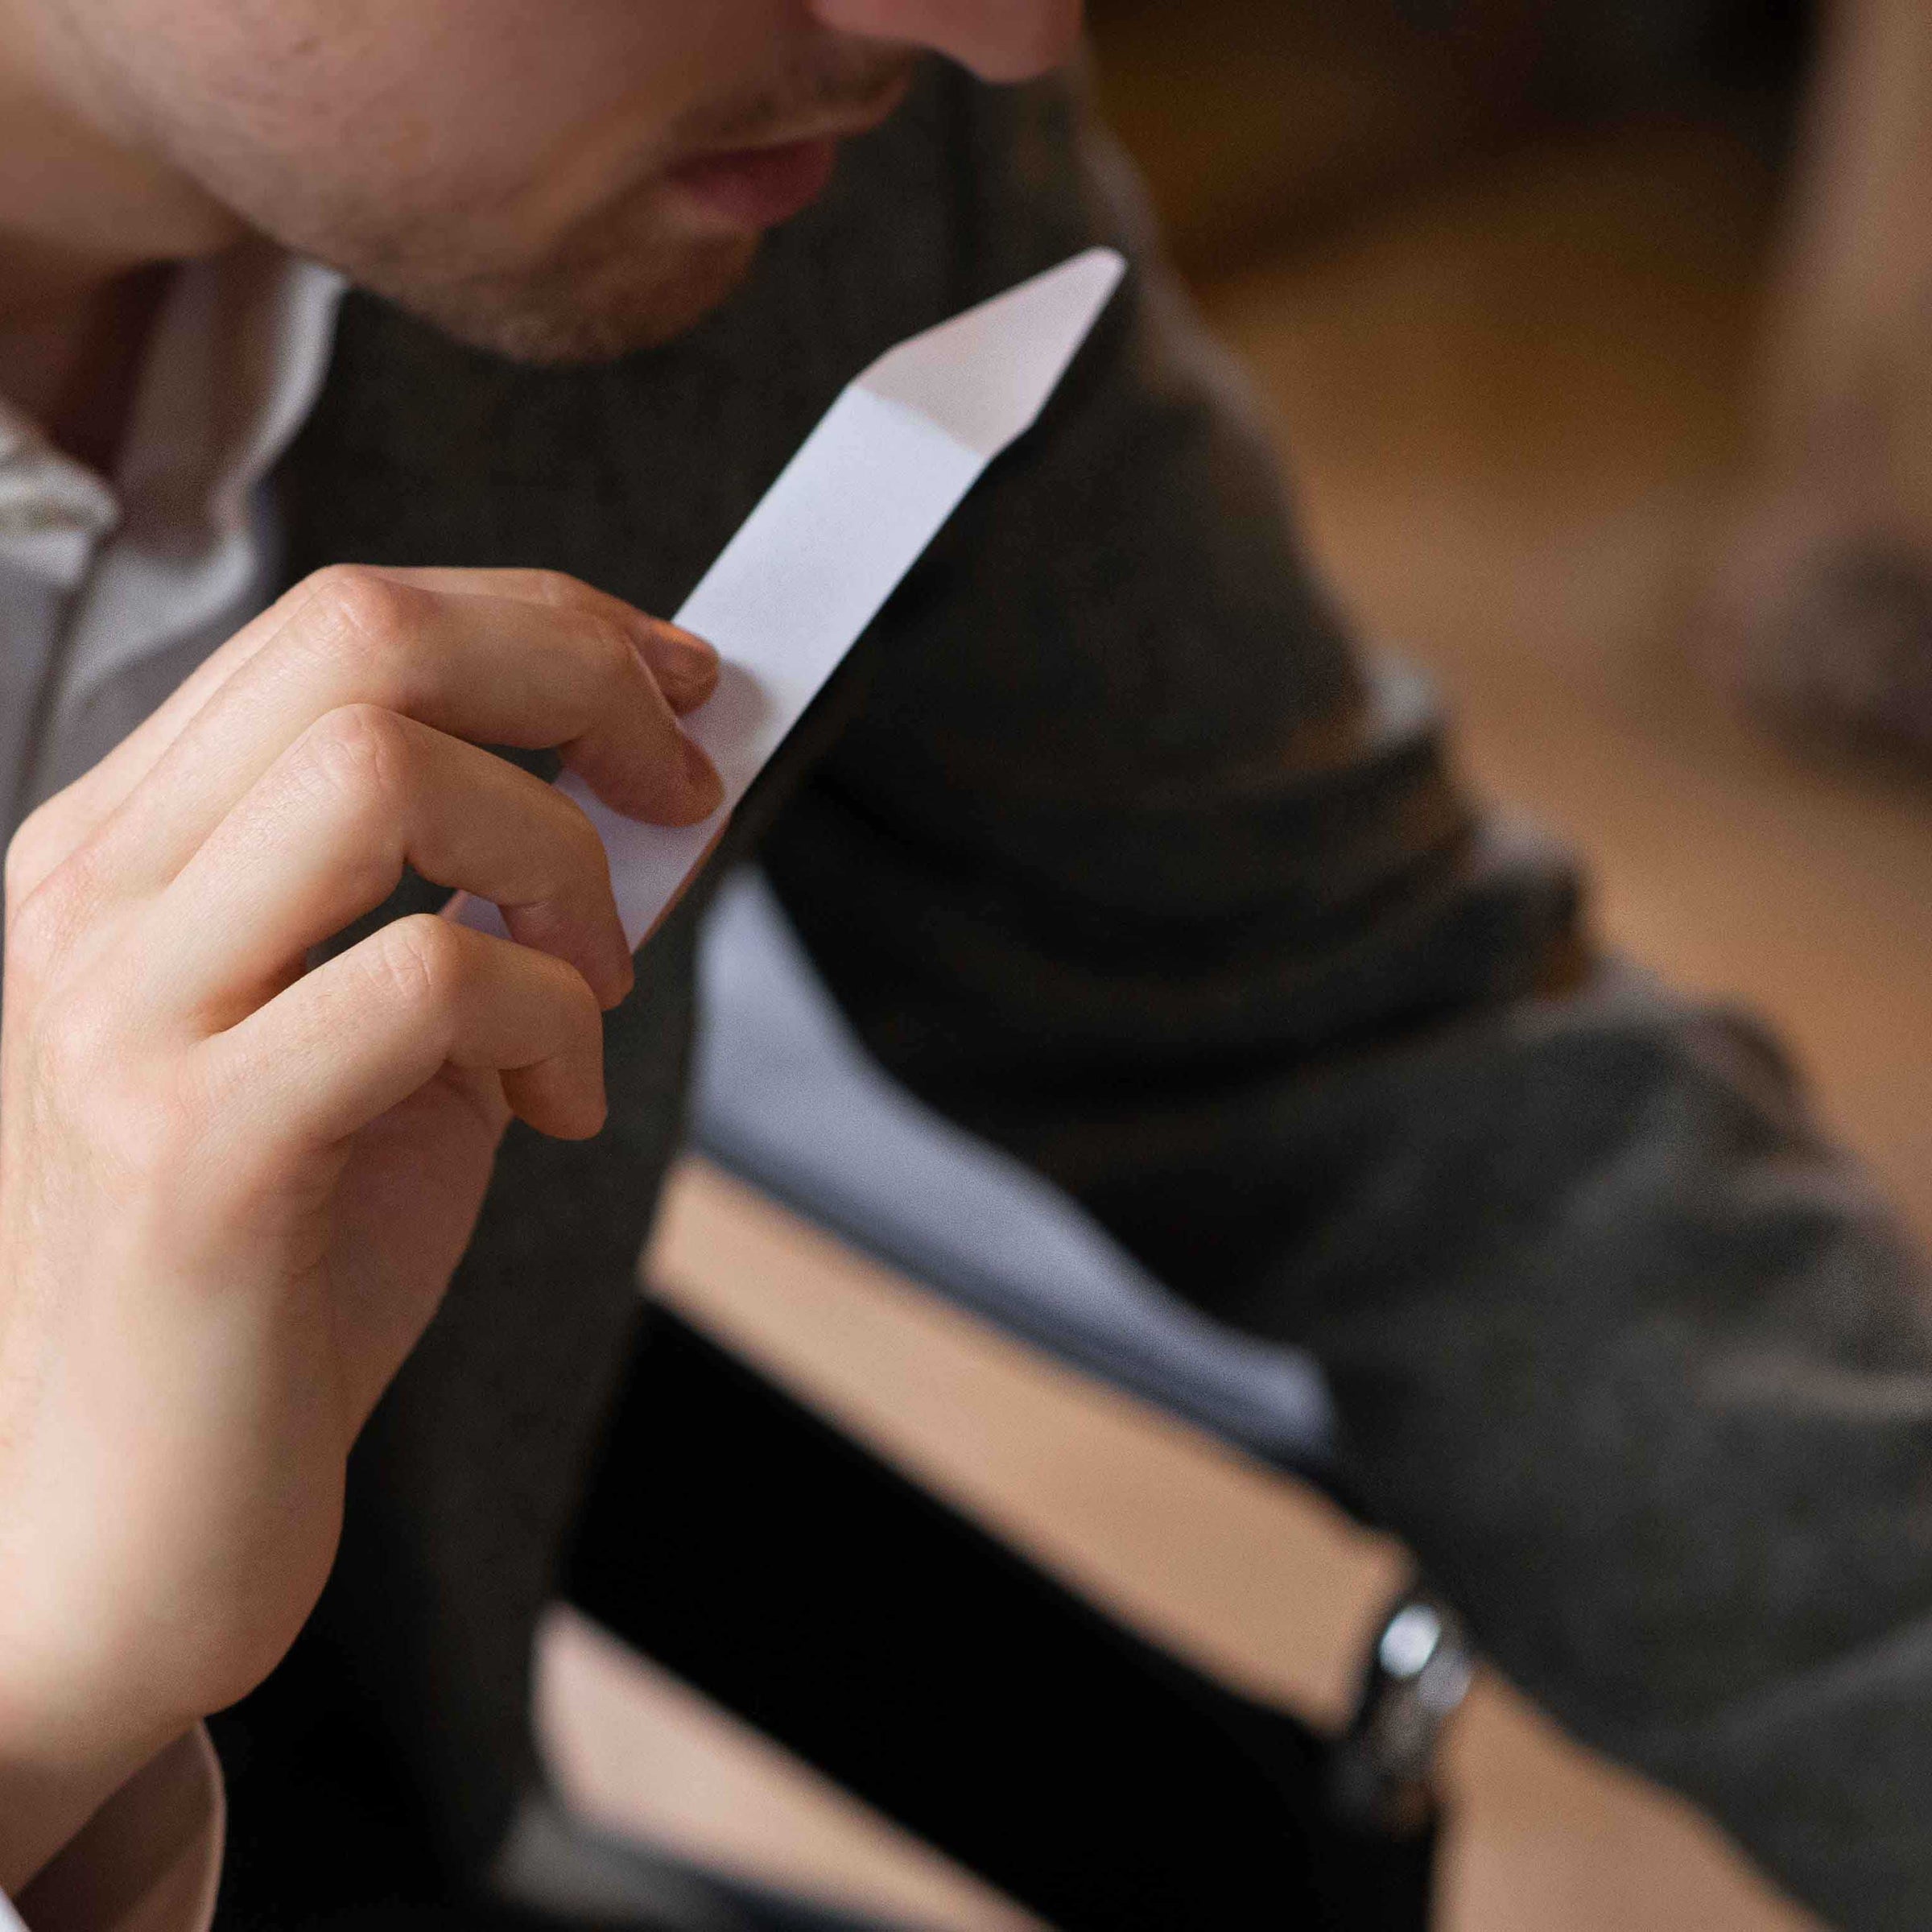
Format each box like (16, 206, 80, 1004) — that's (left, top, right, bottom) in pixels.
(452, 250, 1126, 947)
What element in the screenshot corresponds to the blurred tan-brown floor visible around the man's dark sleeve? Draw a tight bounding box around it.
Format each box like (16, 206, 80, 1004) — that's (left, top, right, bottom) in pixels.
(543, 75, 1932, 1932)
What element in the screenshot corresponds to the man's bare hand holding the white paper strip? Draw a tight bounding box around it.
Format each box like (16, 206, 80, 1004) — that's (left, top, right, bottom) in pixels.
(0, 570, 720, 1888)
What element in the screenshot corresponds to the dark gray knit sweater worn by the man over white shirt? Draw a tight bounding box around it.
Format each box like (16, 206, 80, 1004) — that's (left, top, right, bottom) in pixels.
(229, 69, 1932, 1932)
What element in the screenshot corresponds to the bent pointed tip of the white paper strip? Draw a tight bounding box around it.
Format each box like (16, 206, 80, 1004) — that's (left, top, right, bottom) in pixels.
(856, 247, 1126, 456)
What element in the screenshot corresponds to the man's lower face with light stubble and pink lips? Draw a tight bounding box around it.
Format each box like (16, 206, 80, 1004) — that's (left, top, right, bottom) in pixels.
(0, 0, 1078, 361)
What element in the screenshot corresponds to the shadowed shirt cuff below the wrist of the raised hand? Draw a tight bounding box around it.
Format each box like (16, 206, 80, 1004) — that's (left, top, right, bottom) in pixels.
(0, 1725, 228, 1932)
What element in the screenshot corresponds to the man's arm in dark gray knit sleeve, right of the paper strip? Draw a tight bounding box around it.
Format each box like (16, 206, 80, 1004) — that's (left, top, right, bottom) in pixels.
(767, 68, 1932, 1926)
